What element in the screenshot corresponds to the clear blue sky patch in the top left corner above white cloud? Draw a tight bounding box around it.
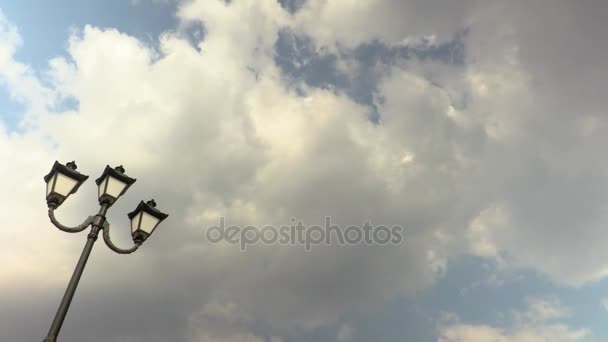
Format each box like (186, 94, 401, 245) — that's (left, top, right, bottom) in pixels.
(2, 0, 177, 69)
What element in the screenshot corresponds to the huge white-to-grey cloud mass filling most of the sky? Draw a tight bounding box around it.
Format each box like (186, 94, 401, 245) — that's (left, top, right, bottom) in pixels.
(0, 0, 608, 341)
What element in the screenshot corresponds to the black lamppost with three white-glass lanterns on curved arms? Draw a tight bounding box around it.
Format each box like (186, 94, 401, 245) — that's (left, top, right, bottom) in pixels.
(44, 162, 169, 342)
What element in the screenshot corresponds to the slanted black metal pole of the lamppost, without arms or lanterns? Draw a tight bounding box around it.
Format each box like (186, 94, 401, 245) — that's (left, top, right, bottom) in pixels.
(44, 204, 108, 342)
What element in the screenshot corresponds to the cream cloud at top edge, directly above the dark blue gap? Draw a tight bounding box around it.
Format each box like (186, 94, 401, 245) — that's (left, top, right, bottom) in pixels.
(293, 0, 476, 47)
